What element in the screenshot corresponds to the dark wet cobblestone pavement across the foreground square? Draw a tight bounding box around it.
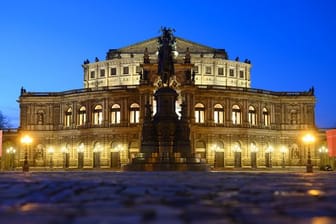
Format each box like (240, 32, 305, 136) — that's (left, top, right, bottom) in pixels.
(0, 171, 336, 224)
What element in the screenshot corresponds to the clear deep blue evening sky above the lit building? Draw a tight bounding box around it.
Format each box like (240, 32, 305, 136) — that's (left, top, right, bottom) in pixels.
(0, 0, 336, 128)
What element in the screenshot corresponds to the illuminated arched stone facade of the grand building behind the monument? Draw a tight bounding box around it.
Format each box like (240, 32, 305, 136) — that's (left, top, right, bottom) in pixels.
(3, 32, 325, 169)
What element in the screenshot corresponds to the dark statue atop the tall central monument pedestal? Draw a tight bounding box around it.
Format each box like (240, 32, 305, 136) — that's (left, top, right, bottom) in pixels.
(158, 27, 176, 85)
